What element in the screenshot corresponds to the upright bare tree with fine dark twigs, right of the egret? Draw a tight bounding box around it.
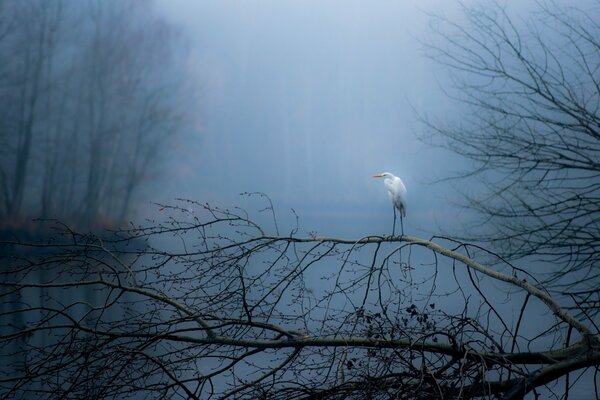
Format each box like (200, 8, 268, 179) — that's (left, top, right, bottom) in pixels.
(425, 1, 600, 304)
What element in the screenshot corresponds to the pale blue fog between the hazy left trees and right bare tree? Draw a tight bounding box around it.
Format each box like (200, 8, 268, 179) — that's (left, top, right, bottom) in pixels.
(158, 1, 460, 236)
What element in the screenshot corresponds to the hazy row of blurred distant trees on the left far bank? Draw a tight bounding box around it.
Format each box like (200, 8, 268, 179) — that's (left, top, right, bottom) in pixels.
(0, 0, 188, 225)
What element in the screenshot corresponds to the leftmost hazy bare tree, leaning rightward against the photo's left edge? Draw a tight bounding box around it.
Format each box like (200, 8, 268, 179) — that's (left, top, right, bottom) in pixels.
(0, 1, 61, 215)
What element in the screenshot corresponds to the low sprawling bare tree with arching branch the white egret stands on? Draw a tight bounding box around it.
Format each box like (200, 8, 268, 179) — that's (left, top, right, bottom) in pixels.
(0, 198, 600, 399)
